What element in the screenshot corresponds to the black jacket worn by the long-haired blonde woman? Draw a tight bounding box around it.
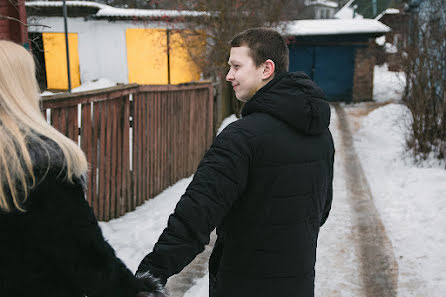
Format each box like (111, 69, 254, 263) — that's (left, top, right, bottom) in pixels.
(0, 140, 161, 297)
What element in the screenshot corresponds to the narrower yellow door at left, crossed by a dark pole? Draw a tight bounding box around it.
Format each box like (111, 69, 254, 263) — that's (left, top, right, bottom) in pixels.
(42, 33, 81, 90)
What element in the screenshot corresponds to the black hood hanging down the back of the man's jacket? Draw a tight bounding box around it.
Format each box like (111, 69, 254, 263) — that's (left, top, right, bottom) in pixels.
(242, 72, 330, 135)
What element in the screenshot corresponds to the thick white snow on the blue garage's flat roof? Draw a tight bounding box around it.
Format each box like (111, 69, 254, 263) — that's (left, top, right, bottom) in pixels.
(285, 19, 390, 36)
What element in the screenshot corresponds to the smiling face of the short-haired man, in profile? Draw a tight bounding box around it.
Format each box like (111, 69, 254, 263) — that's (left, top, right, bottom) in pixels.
(226, 46, 263, 102)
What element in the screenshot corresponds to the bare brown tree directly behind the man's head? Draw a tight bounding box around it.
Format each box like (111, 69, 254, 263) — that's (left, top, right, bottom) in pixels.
(157, 0, 303, 122)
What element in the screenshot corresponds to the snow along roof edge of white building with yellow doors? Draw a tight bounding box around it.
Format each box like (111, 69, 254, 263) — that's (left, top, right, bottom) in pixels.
(25, 1, 206, 17)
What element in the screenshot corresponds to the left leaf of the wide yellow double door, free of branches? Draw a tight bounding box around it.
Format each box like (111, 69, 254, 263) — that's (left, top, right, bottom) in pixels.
(126, 29, 168, 84)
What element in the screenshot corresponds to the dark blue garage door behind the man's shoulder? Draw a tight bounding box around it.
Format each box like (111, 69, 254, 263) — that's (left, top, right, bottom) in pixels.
(290, 45, 355, 102)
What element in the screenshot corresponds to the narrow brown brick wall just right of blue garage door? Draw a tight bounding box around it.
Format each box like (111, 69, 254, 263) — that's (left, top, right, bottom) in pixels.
(352, 45, 376, 102)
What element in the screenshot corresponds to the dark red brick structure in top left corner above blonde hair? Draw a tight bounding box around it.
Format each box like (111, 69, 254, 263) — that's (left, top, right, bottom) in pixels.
(0, 0, 28, 46)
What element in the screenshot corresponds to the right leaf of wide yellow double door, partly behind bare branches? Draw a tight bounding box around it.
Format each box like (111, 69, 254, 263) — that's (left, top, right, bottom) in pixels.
(170, 32, 205, 84)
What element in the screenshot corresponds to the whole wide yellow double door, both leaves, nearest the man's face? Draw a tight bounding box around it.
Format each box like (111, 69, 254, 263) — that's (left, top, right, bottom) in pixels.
(126, 28, 200, 84)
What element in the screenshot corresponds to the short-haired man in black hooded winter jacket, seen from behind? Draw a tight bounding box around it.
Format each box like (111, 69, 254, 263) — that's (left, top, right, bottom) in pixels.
(137, 28, 334, 297)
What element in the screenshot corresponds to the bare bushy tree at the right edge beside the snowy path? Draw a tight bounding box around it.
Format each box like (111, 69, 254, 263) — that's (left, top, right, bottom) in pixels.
(404, 0, 446, 164)
